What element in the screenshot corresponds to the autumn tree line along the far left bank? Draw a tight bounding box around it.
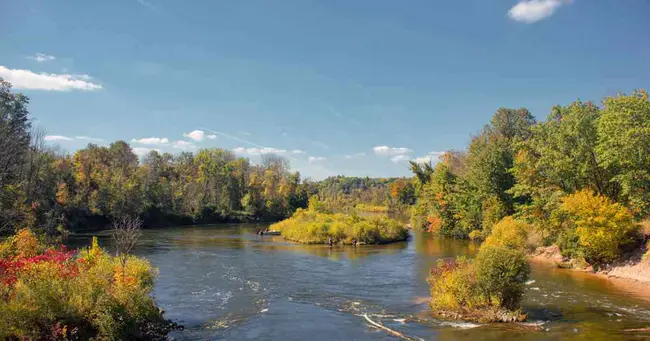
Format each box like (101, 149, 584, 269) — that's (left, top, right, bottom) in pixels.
(0, 80, 315, 234)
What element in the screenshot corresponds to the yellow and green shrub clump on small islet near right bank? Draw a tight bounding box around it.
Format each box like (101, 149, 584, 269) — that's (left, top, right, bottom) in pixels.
(428, 217, 530, 322)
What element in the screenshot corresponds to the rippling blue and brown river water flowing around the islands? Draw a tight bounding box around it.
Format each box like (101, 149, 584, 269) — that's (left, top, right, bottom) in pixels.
(69, 224, 650, 341)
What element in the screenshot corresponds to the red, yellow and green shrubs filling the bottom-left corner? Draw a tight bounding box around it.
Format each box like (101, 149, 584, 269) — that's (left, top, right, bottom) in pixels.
(0, 230, 174, 340)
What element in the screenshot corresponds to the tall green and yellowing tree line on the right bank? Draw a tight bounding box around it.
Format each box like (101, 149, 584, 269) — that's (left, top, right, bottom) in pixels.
(411, 90, 650, 260)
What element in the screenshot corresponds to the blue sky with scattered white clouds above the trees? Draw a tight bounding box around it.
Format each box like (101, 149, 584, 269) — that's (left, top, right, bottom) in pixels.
(0, 0, 650, 179)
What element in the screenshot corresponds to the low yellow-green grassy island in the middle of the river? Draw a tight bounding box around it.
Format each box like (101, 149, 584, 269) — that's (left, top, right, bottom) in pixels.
(271, 209, 409, 244)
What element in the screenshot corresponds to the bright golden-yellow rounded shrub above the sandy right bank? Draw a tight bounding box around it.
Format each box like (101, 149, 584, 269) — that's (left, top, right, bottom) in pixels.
(560, 190, 637, 265)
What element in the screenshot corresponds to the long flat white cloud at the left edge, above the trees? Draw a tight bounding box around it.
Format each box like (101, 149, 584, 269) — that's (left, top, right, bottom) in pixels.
(0, 65, 102, 91)
